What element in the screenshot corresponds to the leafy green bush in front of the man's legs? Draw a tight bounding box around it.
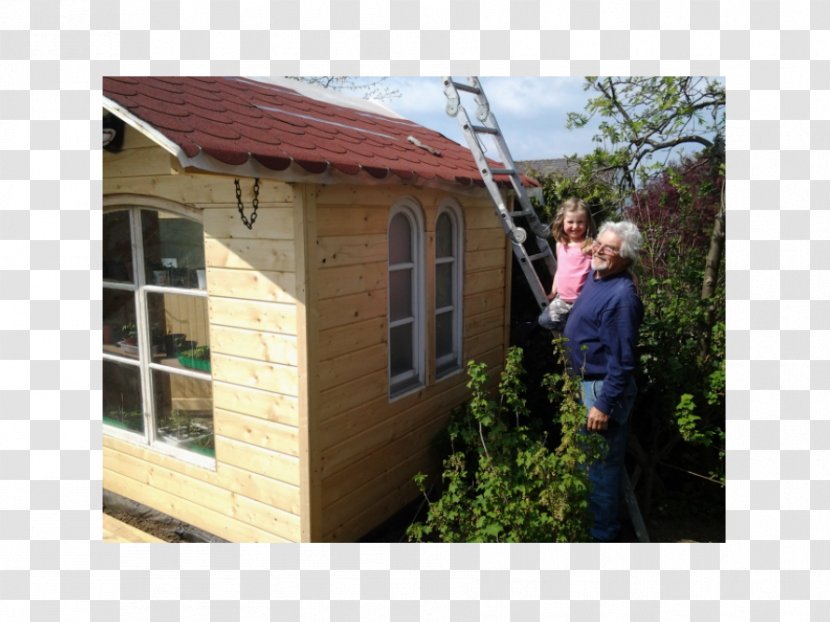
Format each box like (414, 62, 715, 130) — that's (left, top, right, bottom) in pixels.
(407, 341, 602, 542)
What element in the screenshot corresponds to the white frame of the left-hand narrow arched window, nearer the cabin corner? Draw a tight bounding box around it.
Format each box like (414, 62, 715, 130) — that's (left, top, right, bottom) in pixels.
(386, 197, 426, 401)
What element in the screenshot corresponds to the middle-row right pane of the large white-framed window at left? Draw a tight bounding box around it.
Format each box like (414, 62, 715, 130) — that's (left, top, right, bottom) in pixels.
(147, 292, 210, 372)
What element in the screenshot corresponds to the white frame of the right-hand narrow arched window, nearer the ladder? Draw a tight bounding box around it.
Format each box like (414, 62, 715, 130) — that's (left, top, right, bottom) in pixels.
(434, 198, 464, 380)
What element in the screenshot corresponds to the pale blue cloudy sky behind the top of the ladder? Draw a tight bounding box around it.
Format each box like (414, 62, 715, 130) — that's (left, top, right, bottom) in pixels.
(360, 76, 597, 160)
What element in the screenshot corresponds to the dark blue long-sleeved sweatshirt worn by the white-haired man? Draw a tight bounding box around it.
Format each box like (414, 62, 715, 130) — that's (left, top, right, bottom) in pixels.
(564, 270, 643, 414)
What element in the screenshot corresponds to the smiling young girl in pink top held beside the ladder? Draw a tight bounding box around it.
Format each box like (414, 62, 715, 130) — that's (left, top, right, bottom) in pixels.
(539, 197, 596, 332)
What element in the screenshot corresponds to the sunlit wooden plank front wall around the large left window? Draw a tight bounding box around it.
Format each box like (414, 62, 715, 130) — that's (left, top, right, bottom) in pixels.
(103, 128, 308, 542)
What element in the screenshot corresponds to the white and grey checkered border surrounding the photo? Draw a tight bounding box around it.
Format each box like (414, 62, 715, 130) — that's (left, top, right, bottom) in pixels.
(0, 0, 830, 622)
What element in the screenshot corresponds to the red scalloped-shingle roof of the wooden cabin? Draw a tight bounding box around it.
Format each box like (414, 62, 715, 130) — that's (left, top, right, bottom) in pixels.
(103, 77, 533, 186)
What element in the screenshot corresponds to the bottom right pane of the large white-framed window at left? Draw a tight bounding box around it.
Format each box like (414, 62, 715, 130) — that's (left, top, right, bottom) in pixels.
(153, 370, 214, 456)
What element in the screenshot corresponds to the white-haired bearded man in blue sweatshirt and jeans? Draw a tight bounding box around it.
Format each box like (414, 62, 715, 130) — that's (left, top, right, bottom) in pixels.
(564, 222, 643, 542)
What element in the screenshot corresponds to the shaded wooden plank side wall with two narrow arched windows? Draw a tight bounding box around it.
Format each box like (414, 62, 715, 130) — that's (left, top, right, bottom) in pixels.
(308, 186, 510, 541)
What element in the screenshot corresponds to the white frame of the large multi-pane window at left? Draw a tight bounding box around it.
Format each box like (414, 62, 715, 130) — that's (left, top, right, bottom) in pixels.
(101, 207, 216, 469)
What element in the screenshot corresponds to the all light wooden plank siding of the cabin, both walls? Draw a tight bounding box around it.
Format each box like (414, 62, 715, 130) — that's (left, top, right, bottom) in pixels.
(103, 124, 510, 542)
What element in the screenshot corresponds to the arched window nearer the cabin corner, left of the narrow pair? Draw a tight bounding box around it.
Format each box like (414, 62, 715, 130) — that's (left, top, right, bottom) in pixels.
(389, 199, 425, 397)
